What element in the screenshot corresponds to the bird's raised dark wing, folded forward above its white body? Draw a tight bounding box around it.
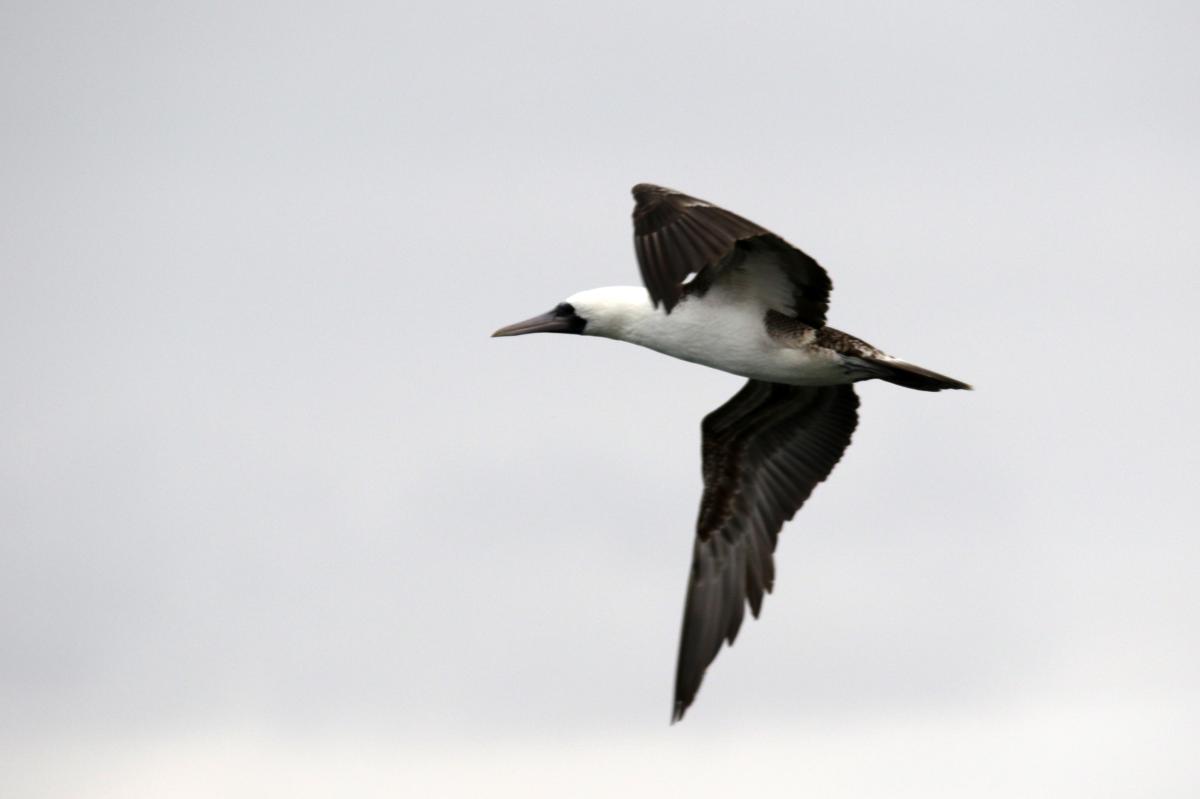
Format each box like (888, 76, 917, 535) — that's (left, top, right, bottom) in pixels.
(634, 184, 833, 328)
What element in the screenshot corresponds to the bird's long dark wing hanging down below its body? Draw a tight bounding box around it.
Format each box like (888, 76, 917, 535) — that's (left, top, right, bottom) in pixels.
(673, 380, 858, 721)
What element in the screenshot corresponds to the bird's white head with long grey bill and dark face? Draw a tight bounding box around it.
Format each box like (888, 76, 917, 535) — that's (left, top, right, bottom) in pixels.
(492, 286, 655, 338)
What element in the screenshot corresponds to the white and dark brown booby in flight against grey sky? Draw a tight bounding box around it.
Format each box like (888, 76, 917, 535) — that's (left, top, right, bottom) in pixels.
(492, 184, 971, 721)
